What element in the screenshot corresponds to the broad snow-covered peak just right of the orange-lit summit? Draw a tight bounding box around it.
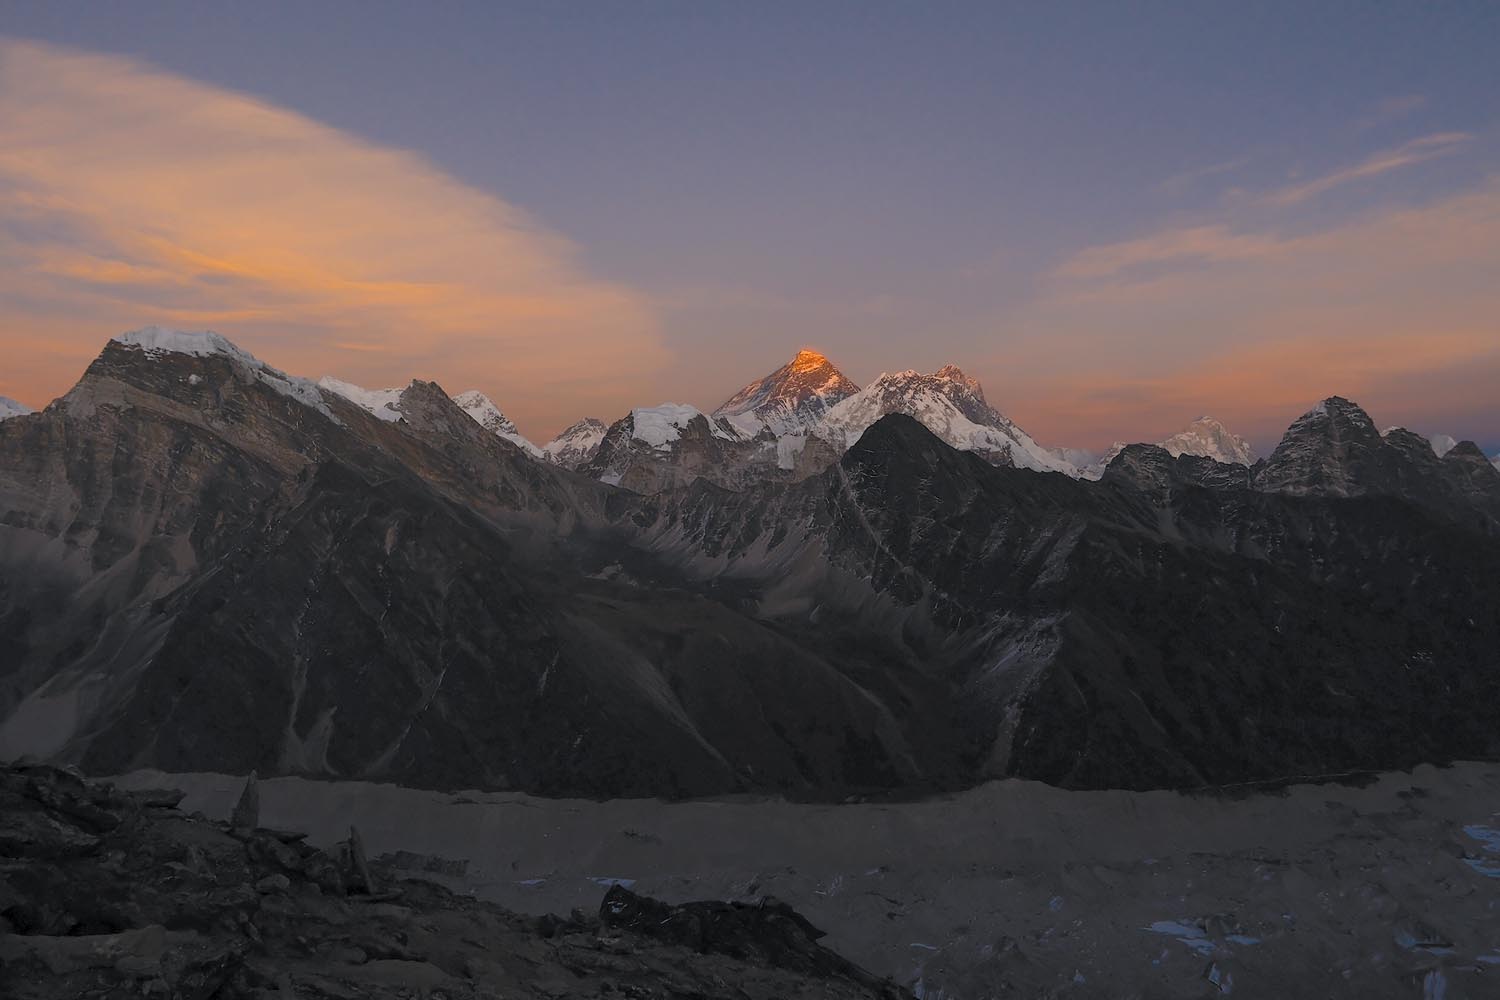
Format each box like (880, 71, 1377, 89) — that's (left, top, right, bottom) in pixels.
(813, 364, 1079, 477)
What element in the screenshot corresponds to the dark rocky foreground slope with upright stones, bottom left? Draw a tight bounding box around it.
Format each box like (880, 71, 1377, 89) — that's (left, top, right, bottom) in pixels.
(0, 766, 908, 1000)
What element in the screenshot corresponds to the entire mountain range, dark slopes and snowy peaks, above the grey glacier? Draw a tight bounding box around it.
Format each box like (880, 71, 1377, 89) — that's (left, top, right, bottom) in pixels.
(0, 330, 1500, 799)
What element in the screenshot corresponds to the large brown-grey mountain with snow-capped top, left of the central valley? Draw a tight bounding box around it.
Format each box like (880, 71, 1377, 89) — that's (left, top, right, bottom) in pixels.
(0, 335, 923, 795)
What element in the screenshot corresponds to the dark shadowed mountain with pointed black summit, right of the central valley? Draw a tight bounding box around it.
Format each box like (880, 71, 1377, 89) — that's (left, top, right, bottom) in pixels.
(615, 417, 1500, 787)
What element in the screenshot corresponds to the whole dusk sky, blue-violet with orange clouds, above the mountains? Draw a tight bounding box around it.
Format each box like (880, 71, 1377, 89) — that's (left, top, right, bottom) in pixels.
(0, 0, 1500, 453)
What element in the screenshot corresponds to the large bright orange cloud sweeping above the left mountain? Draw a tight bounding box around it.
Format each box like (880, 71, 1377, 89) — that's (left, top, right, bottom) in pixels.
(0, 39, 666, 429)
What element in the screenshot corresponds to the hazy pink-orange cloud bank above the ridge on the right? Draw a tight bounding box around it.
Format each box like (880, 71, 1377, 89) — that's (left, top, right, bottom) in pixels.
(989, 178, 1500, 447)
